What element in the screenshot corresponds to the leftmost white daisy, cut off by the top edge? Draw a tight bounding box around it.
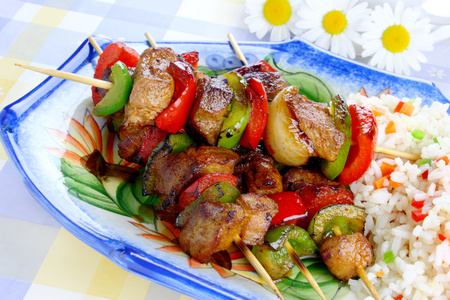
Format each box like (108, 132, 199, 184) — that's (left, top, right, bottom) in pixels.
(244, 0, 301, 42)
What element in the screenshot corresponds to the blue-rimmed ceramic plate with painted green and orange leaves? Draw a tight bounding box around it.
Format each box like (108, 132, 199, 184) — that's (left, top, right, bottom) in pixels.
(0, 37, 448, 299)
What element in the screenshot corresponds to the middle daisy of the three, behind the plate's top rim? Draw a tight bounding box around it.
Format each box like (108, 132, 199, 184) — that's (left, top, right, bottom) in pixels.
(296, 0, 370, 58)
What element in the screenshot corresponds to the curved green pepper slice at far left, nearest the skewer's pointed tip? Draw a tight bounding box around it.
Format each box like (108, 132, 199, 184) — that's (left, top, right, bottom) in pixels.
(92, 61, 132, 117)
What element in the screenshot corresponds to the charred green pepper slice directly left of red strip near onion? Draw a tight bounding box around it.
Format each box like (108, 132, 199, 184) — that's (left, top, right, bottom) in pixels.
(218, 72, 250, 149)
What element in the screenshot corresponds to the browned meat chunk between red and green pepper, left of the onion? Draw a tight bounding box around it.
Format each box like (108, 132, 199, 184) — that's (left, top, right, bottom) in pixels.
(187, 77, 233, 146)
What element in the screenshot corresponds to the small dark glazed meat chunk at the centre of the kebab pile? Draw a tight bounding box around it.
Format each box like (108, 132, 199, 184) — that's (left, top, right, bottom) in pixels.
(233, 152, 283, 195)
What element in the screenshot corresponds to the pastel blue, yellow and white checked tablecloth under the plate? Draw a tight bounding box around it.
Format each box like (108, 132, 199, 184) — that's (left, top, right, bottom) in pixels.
(0, 0, 450, 300)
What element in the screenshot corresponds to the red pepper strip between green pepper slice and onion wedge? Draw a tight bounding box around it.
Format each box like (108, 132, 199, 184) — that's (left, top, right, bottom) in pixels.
(239, 77, 269, 150)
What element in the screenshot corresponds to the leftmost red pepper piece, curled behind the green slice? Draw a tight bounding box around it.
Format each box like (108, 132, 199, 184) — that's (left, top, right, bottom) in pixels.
(92, 42, 139, 105)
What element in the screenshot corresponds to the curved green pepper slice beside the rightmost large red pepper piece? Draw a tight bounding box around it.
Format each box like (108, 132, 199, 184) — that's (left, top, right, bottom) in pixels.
(320, 95, 352, 180)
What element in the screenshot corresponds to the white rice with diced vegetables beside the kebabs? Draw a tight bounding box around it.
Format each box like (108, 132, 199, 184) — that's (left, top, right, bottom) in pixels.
(348, 94, 450, 300)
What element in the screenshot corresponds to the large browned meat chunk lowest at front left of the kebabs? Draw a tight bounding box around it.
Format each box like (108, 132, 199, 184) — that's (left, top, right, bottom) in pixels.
(178, 201, 246, 263)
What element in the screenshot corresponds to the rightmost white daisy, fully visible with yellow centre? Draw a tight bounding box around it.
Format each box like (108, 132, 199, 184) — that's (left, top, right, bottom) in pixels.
(361, 2, 434, 75)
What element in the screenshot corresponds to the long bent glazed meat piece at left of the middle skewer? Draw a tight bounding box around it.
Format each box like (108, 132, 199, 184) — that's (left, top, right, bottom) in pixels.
(144, 146, 238, 223)
